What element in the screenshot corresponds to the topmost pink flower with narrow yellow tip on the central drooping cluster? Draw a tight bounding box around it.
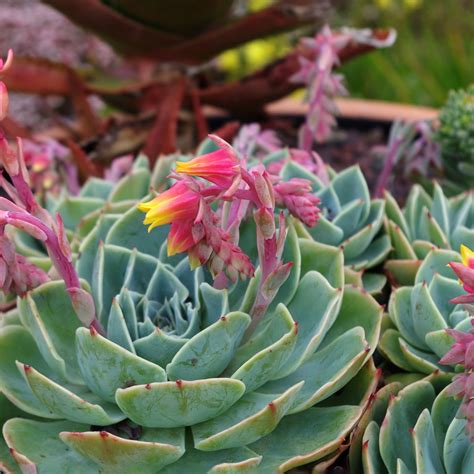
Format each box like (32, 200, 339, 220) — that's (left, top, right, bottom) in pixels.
(176, 135, 241, 189)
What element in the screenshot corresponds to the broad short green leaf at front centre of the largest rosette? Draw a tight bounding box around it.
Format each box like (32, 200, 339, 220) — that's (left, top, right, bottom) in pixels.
(116, 378, 245, 428)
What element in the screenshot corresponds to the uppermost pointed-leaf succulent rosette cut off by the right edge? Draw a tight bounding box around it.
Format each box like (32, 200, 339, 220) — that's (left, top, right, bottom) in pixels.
(385, 183, 474, 285)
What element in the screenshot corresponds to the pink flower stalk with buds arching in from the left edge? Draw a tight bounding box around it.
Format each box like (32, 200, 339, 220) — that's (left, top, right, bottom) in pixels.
(0, 53, 103, 332)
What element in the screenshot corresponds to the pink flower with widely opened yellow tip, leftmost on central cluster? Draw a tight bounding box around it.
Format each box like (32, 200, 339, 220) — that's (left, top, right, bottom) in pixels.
(138, 180, 201, 232)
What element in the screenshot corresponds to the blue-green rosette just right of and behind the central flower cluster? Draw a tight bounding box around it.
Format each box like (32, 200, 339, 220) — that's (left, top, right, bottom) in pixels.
(280, 160, 391, 292)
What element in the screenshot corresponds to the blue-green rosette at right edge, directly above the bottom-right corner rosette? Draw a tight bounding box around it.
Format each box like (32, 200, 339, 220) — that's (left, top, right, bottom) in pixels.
(379, 249, 474, 374)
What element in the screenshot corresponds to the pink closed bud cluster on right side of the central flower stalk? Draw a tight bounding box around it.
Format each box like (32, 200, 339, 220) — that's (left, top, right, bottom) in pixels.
(274, 178, 320, 227)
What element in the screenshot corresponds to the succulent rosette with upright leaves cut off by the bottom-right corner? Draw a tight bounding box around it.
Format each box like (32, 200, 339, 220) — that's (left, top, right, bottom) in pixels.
(349, 376, 474, 474)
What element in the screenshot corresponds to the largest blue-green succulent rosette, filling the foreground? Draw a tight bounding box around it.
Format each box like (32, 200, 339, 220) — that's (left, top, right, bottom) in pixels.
(0, 131, 381, 474)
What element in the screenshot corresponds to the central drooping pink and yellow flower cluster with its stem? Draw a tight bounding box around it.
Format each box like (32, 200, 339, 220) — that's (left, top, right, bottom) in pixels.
(139, 135, 319, 320)
